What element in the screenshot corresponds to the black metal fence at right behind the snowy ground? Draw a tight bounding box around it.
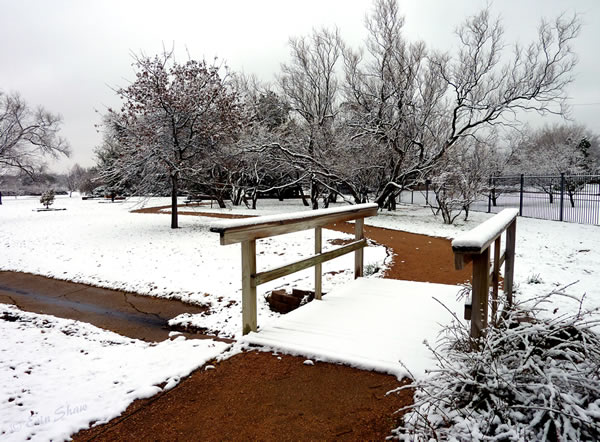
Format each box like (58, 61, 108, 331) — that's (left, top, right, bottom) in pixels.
(471, 174, 600, 225)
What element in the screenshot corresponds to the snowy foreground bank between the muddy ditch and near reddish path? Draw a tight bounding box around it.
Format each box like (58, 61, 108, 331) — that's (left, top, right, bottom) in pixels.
(0, 304, 228, 441)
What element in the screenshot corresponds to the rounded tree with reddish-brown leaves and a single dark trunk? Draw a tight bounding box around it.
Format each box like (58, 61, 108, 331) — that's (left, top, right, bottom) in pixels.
(101, 52, 241, 228)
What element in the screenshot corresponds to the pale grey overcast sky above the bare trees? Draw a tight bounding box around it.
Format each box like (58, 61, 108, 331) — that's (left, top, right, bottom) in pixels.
(0, 0, 600, 172)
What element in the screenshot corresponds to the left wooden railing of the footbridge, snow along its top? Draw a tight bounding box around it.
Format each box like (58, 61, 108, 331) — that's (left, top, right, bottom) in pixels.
(210, 204, 378, 334)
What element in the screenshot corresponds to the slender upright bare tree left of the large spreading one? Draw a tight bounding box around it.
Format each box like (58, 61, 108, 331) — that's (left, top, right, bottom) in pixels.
(272, 29, 352, 209)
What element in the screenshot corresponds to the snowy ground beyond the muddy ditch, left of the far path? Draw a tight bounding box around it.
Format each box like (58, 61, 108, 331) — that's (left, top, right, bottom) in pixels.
(0, 197, 387, 337)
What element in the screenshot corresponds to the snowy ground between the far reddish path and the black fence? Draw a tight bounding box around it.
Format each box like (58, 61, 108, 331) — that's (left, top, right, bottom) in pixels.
(365, 206, 600, 313)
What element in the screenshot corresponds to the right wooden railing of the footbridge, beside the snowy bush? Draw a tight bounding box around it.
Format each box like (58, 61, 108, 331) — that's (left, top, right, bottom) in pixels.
(452, 209, 519, 338)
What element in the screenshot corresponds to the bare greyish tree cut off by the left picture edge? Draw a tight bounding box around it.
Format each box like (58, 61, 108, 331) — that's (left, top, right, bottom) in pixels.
(0, 92, 69, 176)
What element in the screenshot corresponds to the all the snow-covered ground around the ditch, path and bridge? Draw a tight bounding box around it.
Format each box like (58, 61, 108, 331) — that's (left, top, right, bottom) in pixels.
(0, 197, 600, 440)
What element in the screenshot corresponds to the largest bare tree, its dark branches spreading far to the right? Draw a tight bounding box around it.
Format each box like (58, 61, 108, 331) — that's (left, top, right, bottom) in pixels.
(345, 0, 580, 211)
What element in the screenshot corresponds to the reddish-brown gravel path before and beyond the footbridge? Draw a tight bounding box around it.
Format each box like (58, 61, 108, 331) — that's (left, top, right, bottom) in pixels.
(74, 208, 470, 441)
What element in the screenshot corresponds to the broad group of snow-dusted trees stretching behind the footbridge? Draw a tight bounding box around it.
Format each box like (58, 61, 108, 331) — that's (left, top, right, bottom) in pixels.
(2, 0, 580, 227)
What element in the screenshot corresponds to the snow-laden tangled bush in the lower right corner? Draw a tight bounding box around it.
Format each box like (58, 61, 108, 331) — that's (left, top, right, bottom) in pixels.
(394, 290, 600, 441)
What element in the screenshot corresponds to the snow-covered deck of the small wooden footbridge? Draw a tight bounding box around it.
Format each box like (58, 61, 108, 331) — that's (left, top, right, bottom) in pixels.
(242, 278, 463, 377)
